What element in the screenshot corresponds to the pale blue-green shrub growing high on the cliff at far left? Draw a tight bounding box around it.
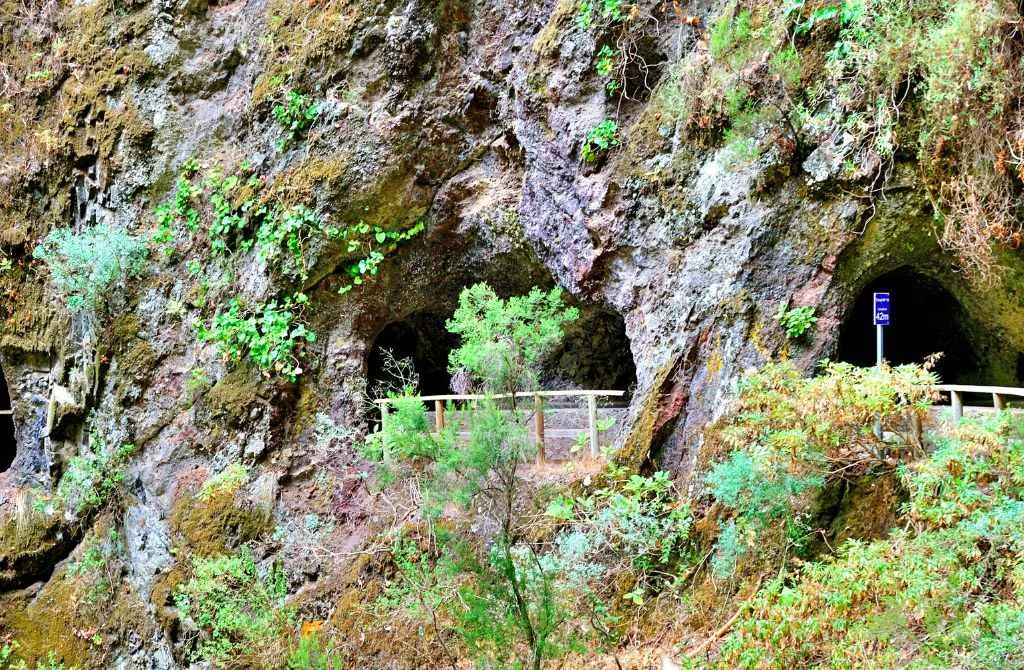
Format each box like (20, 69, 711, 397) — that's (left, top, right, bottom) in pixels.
(33, 225, 150, 312)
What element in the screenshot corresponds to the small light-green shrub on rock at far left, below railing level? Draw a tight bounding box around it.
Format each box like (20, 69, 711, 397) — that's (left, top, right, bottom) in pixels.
(56, 430, 137, 516)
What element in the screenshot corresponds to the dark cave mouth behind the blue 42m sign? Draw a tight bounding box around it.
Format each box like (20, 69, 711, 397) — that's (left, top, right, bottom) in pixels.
(836, 266, 980, 383)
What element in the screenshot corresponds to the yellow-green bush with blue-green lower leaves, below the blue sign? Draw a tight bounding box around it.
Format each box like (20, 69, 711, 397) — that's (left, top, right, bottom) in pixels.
(705, 364, 935, 577)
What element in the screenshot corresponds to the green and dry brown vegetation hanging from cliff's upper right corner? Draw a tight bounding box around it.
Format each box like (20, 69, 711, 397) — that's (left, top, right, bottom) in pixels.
(700, 0, 1024, 283)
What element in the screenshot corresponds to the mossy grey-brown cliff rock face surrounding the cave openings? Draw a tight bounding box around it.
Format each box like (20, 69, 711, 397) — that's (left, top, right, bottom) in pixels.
(0, 0, 1024, 668)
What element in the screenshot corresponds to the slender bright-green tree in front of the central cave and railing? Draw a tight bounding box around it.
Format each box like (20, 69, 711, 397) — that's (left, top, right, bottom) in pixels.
(368, 284, 578, 669)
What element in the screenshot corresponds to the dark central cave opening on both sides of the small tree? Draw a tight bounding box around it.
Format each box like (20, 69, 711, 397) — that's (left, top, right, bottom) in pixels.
(367, 307, 636, 395)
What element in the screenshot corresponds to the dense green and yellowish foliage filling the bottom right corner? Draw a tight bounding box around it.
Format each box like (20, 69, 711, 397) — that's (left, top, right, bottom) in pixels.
(718, 417, 1024, 668)
